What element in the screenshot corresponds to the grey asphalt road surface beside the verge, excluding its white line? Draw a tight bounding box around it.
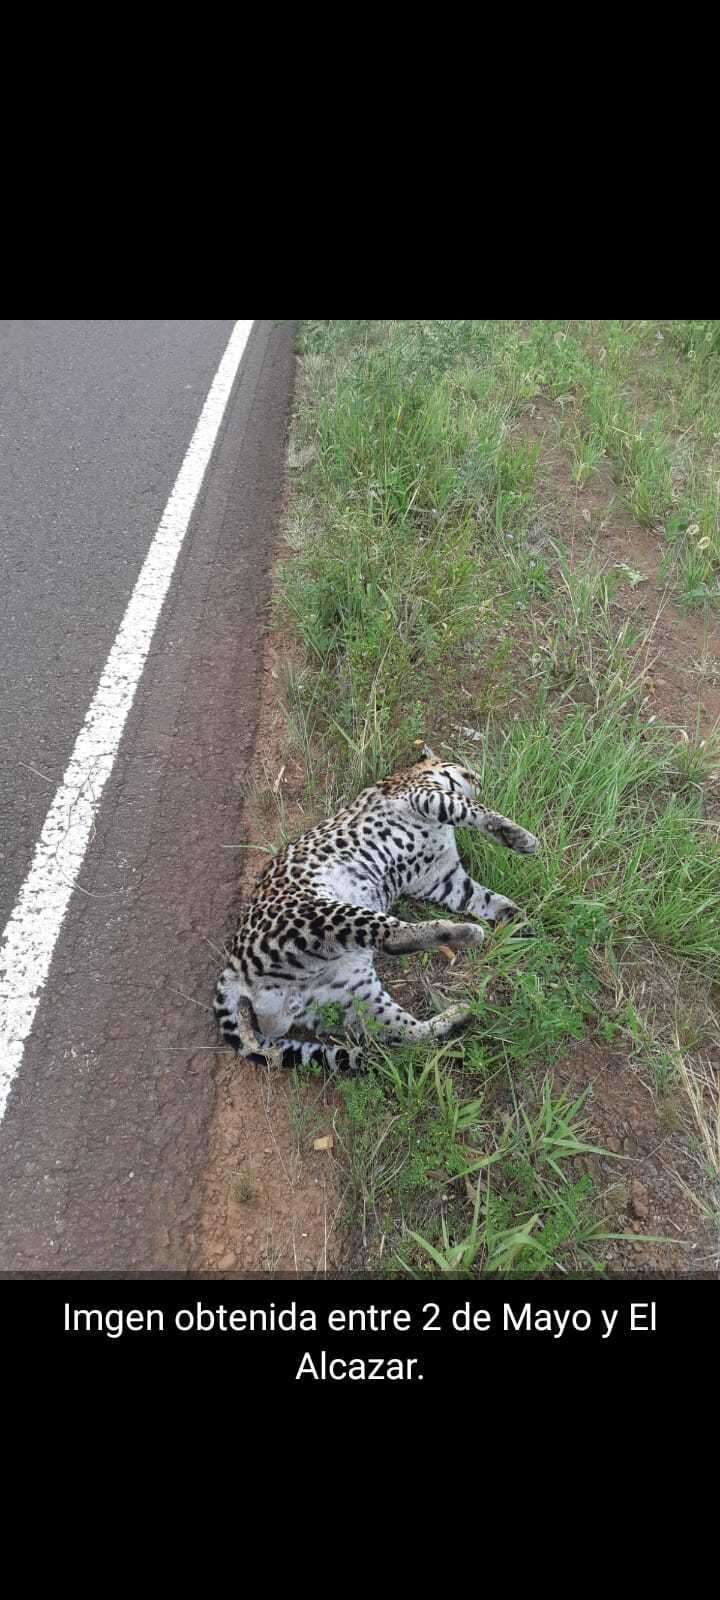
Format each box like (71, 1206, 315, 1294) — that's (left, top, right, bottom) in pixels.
(0, 322, 294, 1272)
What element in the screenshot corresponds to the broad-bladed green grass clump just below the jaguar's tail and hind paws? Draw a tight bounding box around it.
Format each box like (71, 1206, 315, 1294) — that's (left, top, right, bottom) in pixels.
(334, 1054, 614, 1275)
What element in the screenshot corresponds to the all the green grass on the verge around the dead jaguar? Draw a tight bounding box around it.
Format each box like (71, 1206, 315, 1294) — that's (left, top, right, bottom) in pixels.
(280, 322, 720, 1274)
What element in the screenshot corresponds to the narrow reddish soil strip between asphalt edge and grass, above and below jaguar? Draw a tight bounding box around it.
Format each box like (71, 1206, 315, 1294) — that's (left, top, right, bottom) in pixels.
(200, 489, 341, 1277)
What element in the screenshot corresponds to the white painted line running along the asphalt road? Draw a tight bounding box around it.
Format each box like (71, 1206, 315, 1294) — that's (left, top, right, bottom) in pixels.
(0, 322, 253, 1120)
